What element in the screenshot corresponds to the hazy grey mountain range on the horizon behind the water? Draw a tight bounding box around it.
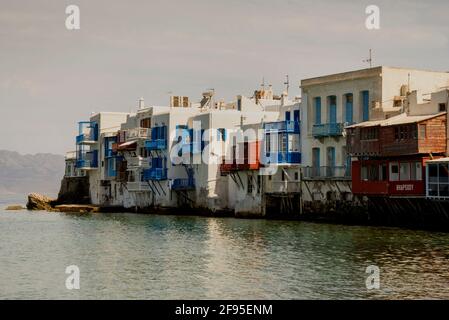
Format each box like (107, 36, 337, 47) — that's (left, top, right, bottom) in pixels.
(0, 150, 65, 196)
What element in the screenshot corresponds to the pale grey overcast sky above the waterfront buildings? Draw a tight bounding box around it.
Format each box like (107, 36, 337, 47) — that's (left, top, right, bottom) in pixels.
(0, 0, 449, 154)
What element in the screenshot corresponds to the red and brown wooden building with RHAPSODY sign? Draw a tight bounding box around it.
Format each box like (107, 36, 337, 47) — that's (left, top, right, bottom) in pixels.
(347, 112, 447, 196)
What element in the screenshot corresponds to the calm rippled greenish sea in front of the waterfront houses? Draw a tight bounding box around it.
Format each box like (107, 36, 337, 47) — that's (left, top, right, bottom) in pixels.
(0, 198, 449, 299)
